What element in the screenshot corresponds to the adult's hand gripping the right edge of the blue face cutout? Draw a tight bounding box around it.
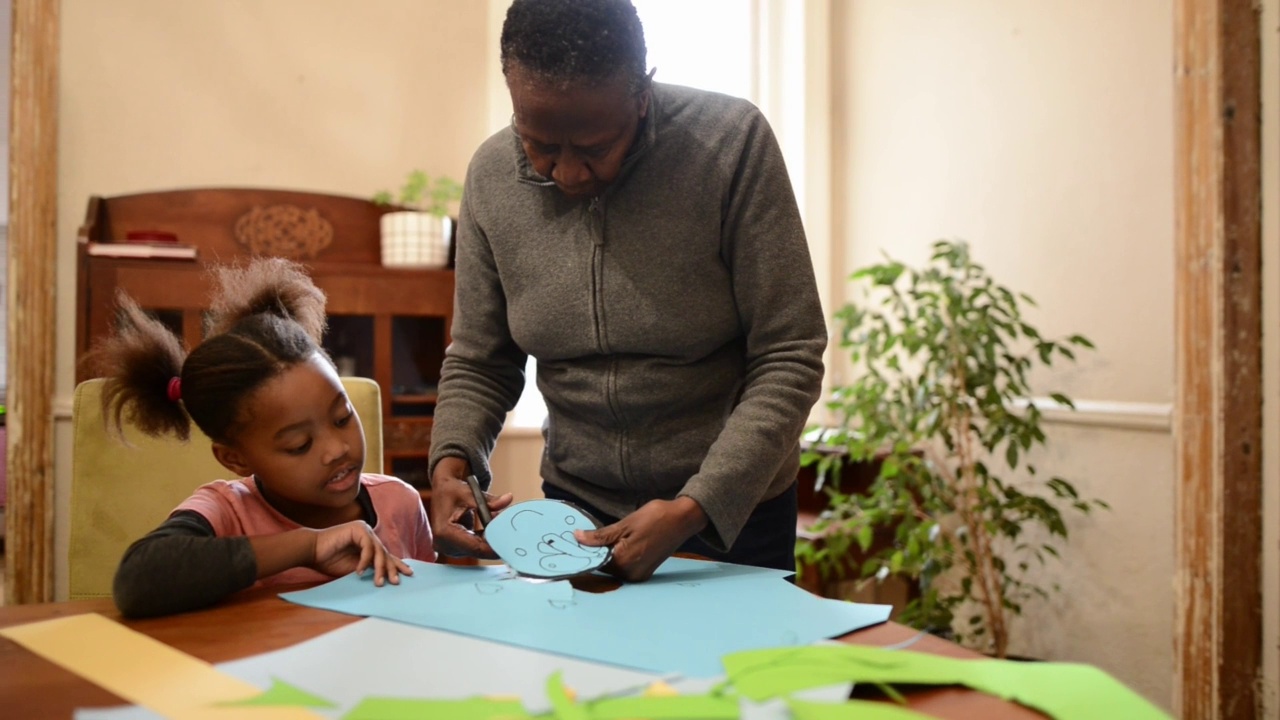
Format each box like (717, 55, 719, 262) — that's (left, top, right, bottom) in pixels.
(573, 496, 707, 583)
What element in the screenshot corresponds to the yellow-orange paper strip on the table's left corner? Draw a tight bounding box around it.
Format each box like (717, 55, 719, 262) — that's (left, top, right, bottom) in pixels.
(0, 614, 317, 720)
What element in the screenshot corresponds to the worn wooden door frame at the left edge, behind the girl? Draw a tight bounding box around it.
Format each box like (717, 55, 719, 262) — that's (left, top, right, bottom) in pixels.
(4, 0, 60, 605)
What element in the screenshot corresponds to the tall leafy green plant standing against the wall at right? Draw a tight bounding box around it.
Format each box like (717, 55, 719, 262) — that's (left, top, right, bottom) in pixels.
(796, 241, 1106, 657)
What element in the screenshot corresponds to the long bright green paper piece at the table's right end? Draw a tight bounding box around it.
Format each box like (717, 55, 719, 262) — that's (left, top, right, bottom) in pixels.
(724, 644, 1169, 720)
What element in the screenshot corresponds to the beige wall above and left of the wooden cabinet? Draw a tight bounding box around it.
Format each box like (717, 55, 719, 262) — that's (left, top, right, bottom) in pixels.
(55, 0, 490, 597)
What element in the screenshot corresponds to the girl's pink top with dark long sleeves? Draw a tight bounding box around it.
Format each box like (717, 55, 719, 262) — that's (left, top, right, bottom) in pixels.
(113, 474, 435, 618)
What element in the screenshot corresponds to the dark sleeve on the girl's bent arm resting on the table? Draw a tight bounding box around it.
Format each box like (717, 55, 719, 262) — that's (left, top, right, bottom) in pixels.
(113, 511, 259, 618)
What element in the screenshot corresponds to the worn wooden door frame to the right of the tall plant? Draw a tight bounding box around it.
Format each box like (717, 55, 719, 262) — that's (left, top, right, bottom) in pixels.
(1174, 0, 1262, 720)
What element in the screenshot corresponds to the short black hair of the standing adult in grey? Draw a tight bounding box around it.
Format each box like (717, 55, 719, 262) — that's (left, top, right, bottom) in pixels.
(502, 0, 649, 92)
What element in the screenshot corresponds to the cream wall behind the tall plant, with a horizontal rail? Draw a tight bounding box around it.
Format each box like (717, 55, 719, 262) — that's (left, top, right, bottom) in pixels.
(832, 0, 1174, 707)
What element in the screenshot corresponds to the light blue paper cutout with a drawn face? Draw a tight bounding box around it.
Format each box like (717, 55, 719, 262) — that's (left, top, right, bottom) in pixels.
(484, 500, 609, 578)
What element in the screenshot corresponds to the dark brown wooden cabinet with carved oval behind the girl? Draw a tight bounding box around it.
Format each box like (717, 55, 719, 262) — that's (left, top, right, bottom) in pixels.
(76, 188, 453, 487)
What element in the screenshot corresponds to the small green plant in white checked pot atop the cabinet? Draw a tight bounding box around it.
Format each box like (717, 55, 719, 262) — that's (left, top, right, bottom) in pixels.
(374, 170, 462, 269)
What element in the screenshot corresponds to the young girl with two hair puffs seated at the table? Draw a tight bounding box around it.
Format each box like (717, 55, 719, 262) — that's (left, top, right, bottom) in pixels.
(90, 259, 435, 618)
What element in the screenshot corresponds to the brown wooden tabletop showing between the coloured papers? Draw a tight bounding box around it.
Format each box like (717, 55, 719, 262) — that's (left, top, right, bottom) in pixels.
(0, 589, 1043, 720)
